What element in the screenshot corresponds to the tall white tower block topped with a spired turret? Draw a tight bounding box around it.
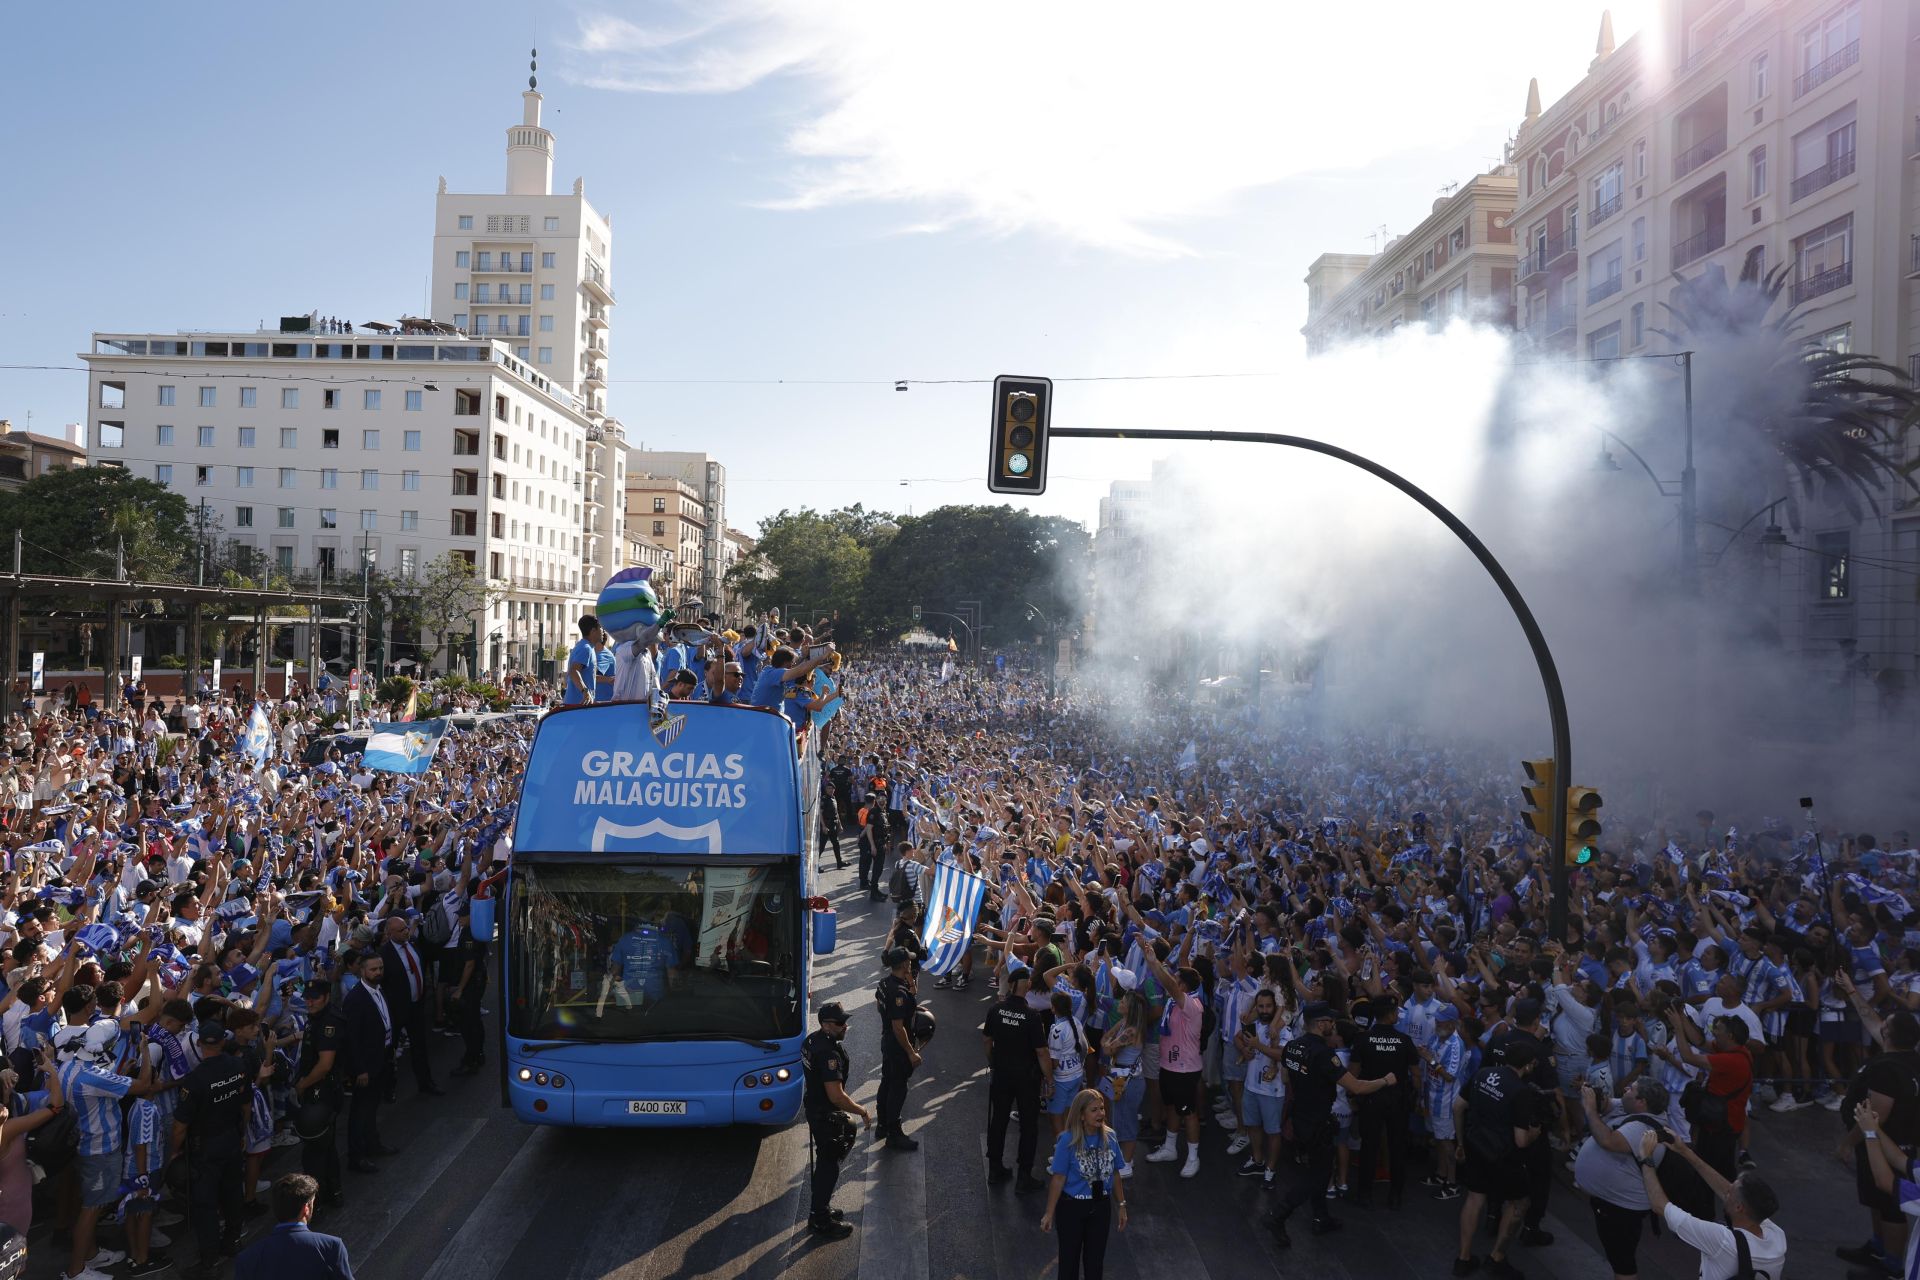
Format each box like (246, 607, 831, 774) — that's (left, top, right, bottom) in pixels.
(432, 62, 626, 589)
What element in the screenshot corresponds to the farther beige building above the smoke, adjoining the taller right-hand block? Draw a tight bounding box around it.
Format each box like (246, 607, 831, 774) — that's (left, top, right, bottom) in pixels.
(1300, 167, 1517, 353)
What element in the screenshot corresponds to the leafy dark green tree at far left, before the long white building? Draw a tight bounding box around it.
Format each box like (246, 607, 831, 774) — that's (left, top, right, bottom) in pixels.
(0, 466, 198, 581)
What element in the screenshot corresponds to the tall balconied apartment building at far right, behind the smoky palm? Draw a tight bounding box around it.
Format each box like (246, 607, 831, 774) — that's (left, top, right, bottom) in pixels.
(1513, 0, 1920, 718)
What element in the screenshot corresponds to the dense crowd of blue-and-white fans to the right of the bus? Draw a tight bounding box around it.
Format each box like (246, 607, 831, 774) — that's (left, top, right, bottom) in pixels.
(824, 660, 1920, 1276)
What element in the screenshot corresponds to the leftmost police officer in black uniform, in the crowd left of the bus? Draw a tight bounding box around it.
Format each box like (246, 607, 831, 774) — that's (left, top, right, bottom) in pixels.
(173, 1019, 252, 1263)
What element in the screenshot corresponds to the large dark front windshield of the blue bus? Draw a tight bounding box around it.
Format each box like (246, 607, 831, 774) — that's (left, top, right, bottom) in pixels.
(507, 856, 801, 1042)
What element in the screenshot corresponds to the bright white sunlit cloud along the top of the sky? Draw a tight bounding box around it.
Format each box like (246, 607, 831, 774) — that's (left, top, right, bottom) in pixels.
(576, 0, 1651, 257)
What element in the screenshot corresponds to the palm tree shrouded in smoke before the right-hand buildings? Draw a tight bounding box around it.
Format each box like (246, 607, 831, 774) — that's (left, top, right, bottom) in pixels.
(1653, 259, 1920, 528)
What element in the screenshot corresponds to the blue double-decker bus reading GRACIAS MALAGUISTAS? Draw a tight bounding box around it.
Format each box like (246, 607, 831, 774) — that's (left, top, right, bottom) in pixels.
(499, 702, 831, 1126)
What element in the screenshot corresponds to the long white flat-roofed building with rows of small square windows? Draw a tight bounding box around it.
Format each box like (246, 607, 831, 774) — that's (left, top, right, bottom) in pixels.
(81, 332, 599, 670)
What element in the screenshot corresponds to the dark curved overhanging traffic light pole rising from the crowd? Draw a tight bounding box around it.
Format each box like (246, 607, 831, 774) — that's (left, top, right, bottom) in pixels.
(1048, 426, 1572, 942)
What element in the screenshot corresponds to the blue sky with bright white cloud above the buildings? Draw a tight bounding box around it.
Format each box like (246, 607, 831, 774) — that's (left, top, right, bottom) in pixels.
(0, 0, 1653, 530)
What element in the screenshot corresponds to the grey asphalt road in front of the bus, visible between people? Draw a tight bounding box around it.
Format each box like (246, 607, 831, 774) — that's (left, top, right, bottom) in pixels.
(29, 869, 1864, 1280)
